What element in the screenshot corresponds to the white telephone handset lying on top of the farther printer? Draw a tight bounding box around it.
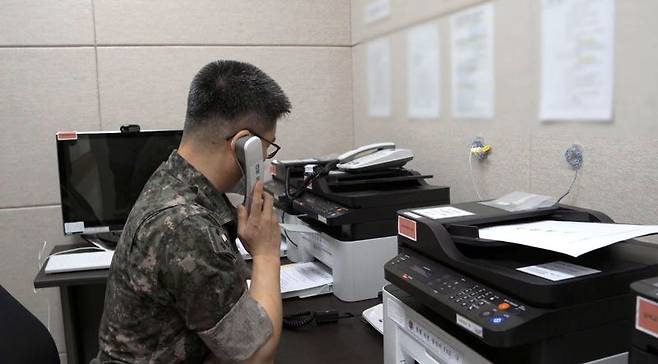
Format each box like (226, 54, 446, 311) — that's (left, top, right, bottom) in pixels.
(336, 142, 414, 173)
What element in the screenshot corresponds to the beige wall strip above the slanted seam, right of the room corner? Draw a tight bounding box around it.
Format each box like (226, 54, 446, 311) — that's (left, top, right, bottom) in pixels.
(352, 0, 487, 44)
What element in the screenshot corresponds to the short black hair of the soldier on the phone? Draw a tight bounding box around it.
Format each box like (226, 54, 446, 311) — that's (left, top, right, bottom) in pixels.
(183, 60, 291, 143)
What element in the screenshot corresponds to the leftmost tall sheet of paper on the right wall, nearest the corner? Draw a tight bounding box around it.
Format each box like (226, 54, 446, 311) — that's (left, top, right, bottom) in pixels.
(368, 38, 391, 118)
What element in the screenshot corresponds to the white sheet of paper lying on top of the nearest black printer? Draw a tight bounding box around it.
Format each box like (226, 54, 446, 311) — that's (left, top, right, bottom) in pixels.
(480, 220, 658, 257)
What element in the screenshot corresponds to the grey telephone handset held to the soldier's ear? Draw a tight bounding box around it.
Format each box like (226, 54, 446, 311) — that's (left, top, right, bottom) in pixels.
(235, 135, 265, 212)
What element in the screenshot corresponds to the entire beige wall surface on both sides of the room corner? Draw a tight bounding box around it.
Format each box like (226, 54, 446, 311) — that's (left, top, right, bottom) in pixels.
(0, 0, 658, 360)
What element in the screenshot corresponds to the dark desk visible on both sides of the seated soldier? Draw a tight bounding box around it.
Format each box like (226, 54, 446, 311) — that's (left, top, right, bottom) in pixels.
(34, 244, 384, 364)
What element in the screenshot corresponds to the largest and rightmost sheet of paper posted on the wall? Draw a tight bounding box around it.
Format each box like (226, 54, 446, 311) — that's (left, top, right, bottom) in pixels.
(539, 0, 615, 121)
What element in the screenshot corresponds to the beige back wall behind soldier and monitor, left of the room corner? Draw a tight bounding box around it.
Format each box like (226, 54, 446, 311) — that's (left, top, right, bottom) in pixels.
(0, 0, 354, 360)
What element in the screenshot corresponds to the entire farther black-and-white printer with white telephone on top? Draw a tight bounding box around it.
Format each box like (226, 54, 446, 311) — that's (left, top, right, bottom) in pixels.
(265, 143, 450, 301)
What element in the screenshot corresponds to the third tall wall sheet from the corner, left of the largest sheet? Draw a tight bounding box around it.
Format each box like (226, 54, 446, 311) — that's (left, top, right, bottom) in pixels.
(450, 3, 494, 119)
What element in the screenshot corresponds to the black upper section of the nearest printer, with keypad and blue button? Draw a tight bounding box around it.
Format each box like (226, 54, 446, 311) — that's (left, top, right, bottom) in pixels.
(385, 202, 658, 363)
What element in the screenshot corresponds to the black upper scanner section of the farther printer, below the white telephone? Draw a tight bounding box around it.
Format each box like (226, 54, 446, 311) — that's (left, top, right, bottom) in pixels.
(265, 160, 450, 240)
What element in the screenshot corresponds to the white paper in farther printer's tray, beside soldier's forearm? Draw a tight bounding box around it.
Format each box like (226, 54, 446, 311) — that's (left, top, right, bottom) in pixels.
(281, 262, 334, 293)
